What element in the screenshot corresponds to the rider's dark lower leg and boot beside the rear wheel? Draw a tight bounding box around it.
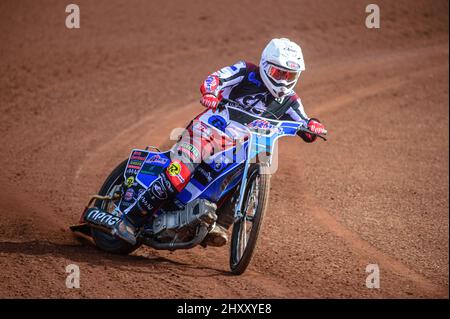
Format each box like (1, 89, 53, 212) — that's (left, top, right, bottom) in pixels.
(113, 172, 182, 245)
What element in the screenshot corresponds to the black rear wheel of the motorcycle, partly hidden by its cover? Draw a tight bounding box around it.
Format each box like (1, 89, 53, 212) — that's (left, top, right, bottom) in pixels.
(91, 160, 140, 255)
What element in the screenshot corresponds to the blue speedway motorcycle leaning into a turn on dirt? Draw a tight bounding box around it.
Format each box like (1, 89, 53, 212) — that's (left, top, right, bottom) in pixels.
(70, 99, 326, 275)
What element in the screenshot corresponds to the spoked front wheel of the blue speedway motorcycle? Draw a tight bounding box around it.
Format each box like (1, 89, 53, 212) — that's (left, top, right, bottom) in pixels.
(230, 164, 270, 275)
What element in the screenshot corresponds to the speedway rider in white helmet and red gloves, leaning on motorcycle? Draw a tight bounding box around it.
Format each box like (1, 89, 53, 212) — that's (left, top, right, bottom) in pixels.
(114, 38, 326, 246)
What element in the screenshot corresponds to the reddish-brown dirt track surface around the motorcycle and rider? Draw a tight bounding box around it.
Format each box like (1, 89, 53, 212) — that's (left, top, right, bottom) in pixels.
(0, 0, 449, 298)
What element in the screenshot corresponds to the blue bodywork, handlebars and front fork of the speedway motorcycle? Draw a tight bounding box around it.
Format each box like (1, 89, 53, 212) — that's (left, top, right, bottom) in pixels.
(120, 100, 311, 218)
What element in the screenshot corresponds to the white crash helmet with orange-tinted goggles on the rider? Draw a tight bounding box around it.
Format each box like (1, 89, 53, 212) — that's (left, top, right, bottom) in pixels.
(259, 38, 305, 98)
